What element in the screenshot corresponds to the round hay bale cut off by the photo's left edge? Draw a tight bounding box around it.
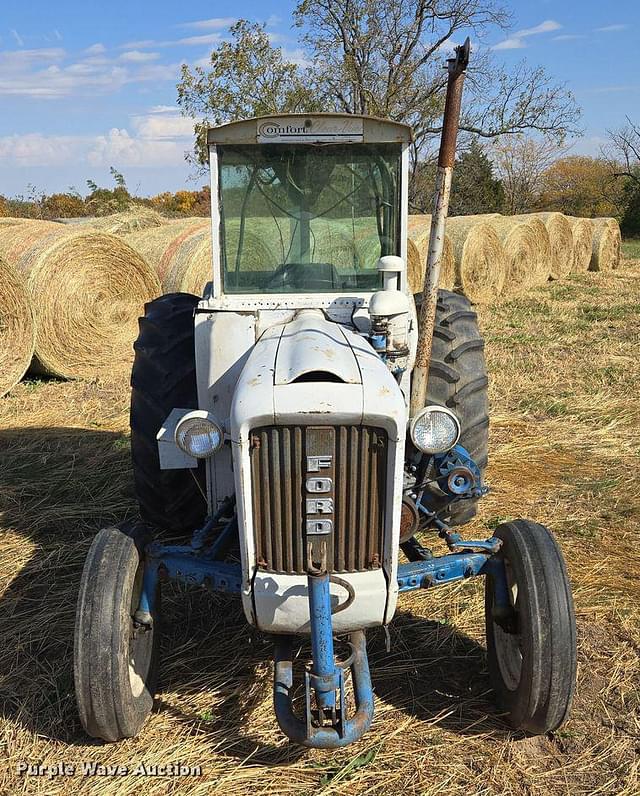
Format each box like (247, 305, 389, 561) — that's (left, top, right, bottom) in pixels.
(0, 257, 36, 398)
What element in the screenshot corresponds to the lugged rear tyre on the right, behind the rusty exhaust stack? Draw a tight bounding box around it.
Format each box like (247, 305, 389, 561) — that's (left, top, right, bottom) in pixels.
(427, 290, 489, 525)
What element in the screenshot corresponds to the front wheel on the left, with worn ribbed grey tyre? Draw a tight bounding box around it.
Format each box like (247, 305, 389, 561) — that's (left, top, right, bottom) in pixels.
(74, 527, 159, 741)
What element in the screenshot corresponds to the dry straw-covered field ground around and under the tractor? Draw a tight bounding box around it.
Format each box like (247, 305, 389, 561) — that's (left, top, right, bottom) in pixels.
(0, 261, 640, 796)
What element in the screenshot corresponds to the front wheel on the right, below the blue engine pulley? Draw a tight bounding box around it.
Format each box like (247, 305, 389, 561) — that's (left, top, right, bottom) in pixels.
(485, 520, 577, 735)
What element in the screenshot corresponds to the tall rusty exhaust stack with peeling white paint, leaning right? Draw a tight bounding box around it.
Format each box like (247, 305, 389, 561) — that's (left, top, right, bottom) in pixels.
(410, 37, 471, 417)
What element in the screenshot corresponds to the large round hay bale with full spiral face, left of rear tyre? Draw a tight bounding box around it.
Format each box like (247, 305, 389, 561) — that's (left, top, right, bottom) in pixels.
(0, 222, 160, 378)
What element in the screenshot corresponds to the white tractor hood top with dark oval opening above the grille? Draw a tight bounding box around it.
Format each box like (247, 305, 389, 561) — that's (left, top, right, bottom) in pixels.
(228, 310, 406, 443)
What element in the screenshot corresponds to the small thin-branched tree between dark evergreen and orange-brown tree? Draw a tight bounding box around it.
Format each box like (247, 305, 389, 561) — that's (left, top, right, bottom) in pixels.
(492, 134, 562, 215)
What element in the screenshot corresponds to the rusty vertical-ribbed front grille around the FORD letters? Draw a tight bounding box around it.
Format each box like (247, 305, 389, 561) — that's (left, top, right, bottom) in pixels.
(251, 426, 388, 574)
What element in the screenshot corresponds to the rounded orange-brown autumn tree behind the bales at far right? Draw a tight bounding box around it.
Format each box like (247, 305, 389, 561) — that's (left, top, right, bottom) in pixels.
(538, 155, 624, 218)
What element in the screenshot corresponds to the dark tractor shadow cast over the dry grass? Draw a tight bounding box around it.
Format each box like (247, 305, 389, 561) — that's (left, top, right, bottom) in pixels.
(0, 428, 504, 765)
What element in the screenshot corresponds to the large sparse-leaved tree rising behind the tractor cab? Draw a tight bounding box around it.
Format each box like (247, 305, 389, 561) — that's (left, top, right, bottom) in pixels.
(178, 0, 579, 170)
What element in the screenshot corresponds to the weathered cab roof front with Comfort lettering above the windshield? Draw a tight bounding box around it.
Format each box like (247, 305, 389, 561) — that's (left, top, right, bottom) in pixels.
(207, 113, 413, 145)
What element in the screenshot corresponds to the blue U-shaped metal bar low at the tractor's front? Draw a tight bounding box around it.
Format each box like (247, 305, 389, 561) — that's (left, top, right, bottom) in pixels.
(273, 630, 373, 749)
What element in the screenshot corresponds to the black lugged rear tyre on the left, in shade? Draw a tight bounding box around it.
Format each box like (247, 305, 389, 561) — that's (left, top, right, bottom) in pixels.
(130, 293, 206, 532)
